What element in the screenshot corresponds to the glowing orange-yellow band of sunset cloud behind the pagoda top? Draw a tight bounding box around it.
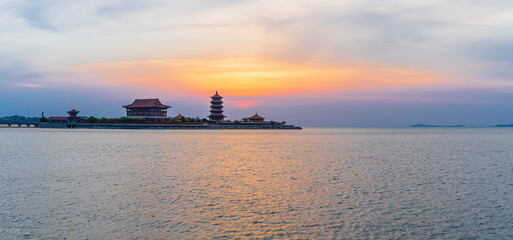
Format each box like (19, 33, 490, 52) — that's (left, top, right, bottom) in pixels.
(69, 59, 440, 96)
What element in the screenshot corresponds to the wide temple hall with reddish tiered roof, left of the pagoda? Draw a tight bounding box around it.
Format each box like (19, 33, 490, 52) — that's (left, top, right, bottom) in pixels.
(123, 98, 171, 119)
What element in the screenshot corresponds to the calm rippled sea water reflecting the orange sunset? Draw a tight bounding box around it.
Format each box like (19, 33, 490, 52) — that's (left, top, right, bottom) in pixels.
(0, 128, 513, 239)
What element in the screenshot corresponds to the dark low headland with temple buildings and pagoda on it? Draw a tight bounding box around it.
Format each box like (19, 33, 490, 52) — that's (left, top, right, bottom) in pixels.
(36, 91, 302, 129)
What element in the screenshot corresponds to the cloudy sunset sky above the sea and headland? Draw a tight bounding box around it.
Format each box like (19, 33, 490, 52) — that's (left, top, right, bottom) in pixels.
(0, 0, 513, 127)
